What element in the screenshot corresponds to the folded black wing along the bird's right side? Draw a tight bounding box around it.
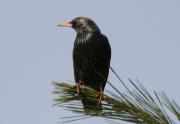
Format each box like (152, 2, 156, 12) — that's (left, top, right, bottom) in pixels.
(91, 34, 111, 89)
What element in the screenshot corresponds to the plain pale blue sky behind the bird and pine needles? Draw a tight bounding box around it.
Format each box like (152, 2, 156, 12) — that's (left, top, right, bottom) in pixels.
(0, 0, 180, 124)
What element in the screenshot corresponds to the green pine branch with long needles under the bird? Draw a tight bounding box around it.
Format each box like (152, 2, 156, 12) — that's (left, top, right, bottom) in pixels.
(53, 70, 180, 124)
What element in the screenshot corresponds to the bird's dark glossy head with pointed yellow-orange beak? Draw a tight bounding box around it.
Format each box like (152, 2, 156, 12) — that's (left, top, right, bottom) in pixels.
(58, 17, 100, 33)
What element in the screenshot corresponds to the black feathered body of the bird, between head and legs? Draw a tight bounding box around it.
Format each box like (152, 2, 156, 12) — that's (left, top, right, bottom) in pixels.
(73, 32, 111, 91)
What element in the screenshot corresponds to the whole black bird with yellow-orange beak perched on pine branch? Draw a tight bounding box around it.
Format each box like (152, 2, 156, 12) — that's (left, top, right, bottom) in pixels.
(58, 17, 111, 108)
